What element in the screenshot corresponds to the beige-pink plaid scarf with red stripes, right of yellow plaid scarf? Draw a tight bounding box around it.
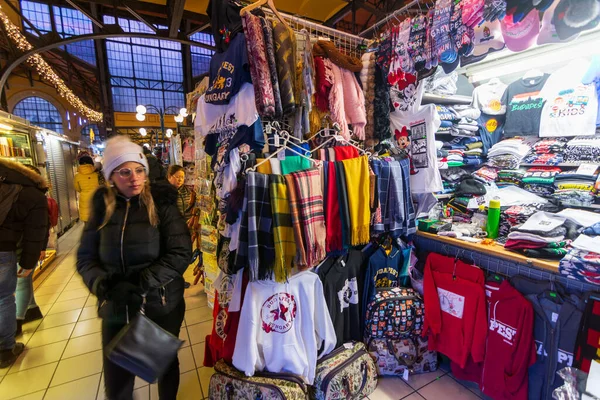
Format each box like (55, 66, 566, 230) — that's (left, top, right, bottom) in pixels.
(290, 168, 327, 268)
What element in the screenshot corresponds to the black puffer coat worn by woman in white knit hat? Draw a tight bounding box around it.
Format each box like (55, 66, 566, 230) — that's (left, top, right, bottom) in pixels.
(77, 183, 192, 320)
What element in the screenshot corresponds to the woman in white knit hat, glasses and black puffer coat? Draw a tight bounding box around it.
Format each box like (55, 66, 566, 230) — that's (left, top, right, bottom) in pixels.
(77, 136, 191, 400)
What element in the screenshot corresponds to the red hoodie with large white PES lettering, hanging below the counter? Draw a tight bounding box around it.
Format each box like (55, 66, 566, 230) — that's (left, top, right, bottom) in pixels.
(452, 281, 536, 400)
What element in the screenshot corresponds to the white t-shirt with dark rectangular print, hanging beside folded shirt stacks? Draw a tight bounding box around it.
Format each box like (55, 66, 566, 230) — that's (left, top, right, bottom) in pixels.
(390, 104, 443, 193)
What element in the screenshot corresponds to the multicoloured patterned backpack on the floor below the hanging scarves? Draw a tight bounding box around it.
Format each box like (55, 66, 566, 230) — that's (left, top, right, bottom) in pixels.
(364, 287, 437, 379)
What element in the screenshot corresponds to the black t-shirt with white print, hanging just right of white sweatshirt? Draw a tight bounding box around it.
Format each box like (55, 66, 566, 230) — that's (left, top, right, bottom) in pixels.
(318, 250, 364, 347)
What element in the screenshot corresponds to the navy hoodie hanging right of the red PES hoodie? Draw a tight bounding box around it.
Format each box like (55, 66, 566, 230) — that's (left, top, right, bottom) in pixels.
(512, 277, 583, 400)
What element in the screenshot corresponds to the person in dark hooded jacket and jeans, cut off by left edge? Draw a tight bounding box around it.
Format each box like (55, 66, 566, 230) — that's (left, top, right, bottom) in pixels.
(0, 160, 48, 368)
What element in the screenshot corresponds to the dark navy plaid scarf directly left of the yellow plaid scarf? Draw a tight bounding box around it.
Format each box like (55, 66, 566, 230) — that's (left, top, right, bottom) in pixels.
(246, 172, 275, 281)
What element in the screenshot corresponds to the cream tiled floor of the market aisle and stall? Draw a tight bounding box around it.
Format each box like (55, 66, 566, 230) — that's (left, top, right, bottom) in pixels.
(0, 226, 488, 400)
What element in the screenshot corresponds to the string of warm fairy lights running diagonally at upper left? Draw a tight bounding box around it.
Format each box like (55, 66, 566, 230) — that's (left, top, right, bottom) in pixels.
(0, 7, 103, 122)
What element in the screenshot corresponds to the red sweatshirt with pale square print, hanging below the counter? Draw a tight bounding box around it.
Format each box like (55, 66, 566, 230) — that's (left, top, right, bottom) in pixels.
(423, 253, 487, 368)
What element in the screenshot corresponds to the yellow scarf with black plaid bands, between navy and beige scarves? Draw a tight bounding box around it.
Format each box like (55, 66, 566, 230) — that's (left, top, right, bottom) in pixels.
(269, 175, 296, 282)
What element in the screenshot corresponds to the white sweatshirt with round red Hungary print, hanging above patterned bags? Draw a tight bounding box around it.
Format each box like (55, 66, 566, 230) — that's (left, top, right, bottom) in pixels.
(233, 271, 337, 384)
